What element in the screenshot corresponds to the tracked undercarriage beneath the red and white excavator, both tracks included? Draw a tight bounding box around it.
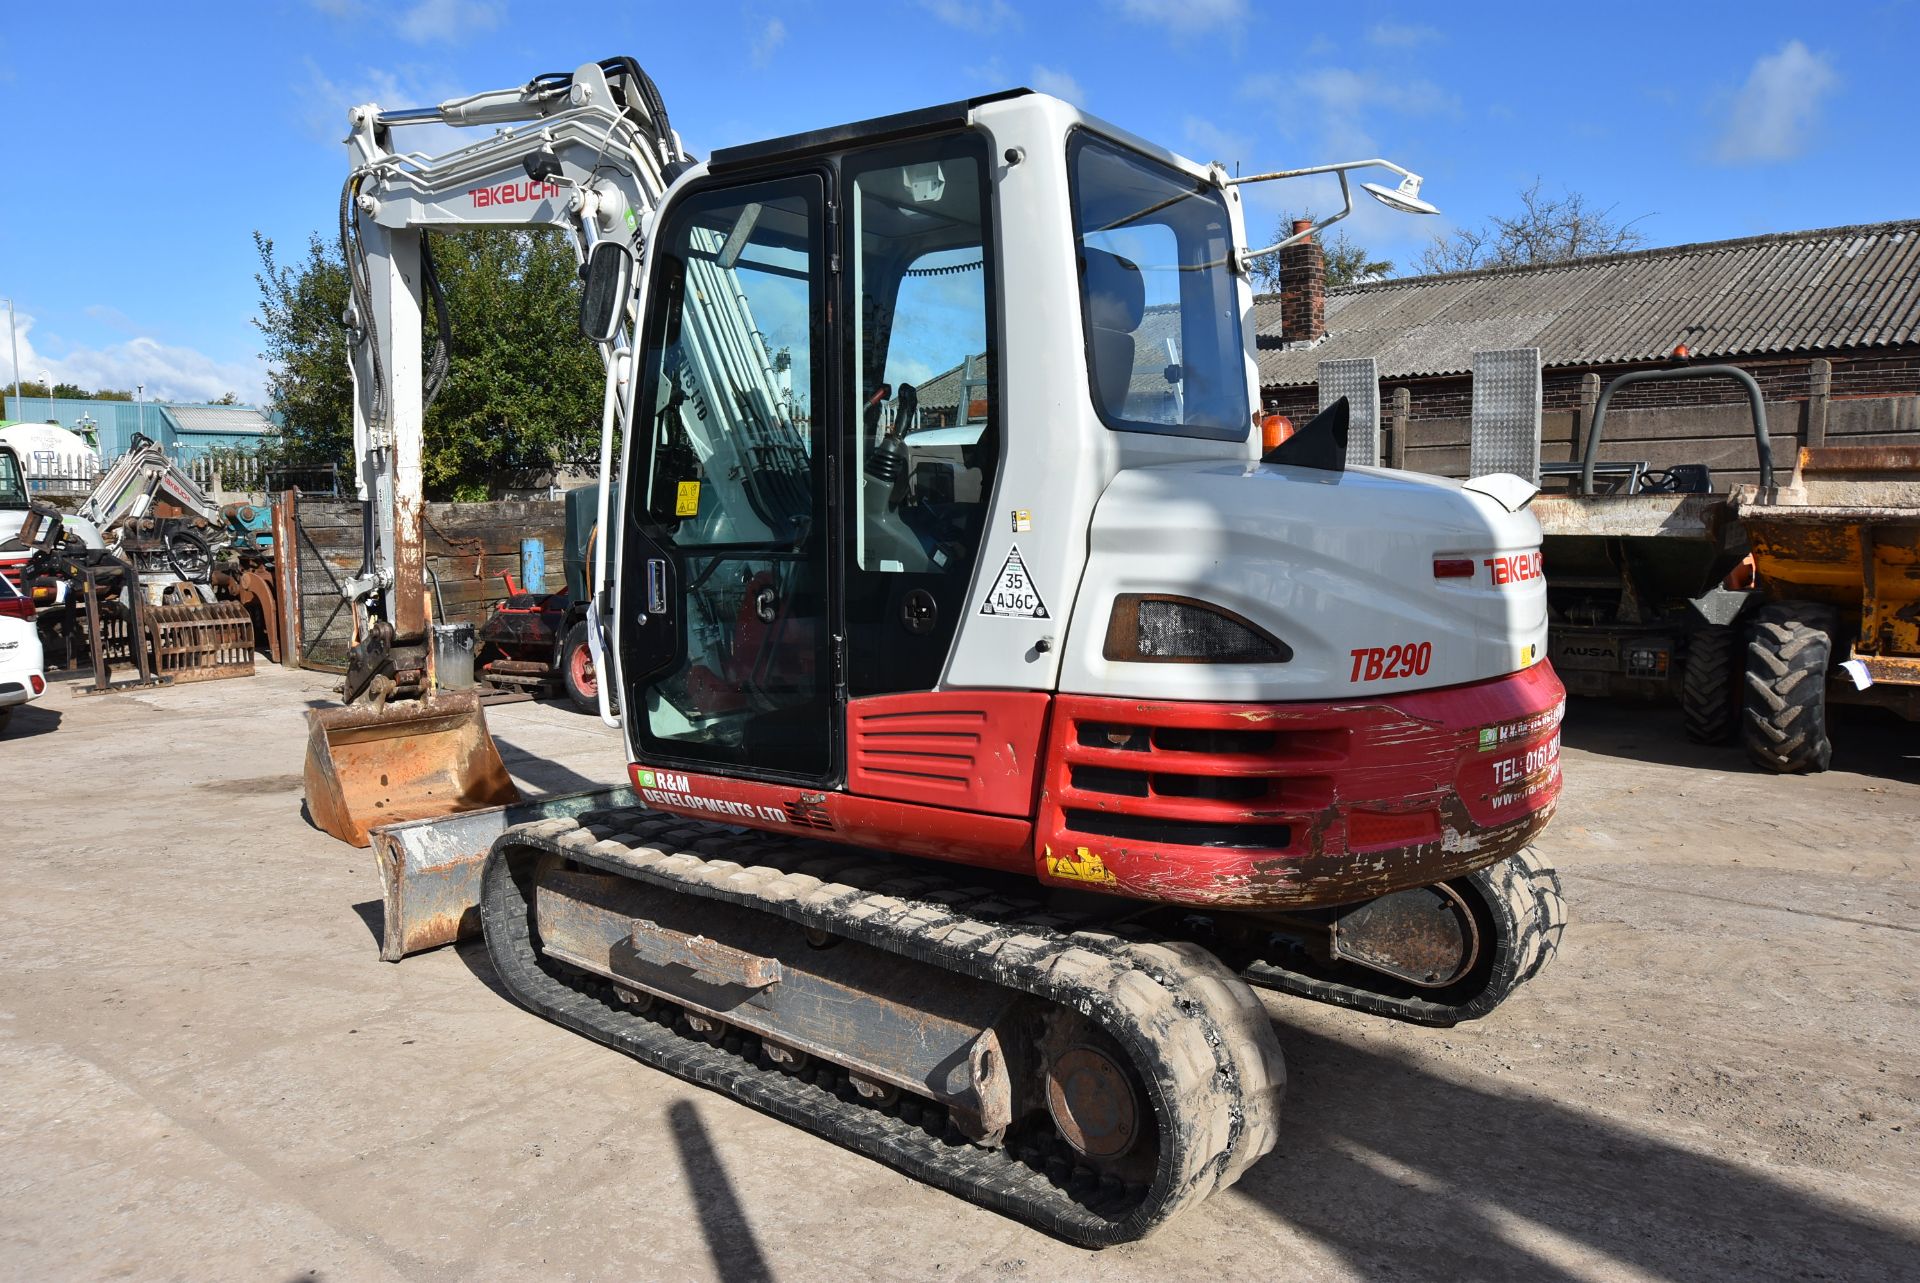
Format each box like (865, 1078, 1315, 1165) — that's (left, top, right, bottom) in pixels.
(480, 811, 1565, 1247)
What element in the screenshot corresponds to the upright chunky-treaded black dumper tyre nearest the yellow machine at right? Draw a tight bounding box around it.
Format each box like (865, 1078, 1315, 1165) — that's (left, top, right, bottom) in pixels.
(1743, 601, 1834, 774)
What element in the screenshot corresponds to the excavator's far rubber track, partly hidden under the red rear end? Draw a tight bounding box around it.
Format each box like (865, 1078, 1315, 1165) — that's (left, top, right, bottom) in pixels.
(1240, 847, 1567, 1028)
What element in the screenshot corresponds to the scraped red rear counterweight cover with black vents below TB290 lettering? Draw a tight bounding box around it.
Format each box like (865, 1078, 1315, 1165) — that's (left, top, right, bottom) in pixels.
(1037, 663, 1565, 908)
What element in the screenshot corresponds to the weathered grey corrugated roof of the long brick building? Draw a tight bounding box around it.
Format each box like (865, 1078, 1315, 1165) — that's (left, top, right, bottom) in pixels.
(1254, 219, 1920, 388)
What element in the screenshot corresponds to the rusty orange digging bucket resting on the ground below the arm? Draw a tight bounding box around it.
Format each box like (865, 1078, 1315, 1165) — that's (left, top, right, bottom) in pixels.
(307, 691, 520, 847)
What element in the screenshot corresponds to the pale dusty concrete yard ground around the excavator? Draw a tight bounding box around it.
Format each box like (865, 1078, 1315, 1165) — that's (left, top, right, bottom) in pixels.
(0, 666, 1920, 1281)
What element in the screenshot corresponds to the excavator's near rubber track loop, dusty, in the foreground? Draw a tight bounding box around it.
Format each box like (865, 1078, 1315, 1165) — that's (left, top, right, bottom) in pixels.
(480, 809, 1286, 1247)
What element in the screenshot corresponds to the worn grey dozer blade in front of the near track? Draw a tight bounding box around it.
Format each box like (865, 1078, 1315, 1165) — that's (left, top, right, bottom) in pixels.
(372, 784, 641, 962)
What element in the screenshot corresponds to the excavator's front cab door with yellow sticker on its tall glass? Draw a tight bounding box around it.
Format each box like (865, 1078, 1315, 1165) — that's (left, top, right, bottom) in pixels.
(620, 173, 839, 782)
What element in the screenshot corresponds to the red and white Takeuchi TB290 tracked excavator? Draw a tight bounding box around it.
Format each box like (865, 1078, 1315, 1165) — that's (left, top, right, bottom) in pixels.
(309, 60, 1565, 1245)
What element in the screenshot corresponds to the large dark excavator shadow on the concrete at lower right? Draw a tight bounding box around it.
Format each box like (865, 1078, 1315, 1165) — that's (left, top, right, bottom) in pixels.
(1236, 1026, 1920, 1281)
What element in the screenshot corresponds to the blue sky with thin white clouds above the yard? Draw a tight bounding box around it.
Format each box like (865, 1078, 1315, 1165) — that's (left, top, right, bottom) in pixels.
(0, 0, 1920, 398)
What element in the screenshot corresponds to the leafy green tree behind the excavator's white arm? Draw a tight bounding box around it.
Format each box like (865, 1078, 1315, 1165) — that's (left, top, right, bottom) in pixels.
(253, 229, 603, 499)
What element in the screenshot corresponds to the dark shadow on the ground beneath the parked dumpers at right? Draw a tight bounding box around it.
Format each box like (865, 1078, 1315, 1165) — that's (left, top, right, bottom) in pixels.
(1561, 699, 1920, 782)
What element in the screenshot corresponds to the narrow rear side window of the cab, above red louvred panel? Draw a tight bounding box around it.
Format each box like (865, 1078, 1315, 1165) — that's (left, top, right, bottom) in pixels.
(839, 133, 1000, 699)
